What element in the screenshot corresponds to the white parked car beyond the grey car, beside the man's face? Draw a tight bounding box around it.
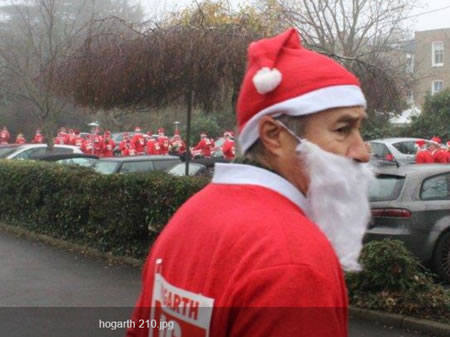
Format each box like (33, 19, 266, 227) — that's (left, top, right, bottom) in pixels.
(369, 138, 430, 165)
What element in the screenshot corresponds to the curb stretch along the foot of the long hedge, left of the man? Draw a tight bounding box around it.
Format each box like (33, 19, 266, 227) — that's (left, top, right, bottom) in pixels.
(0, 222, 144, 267)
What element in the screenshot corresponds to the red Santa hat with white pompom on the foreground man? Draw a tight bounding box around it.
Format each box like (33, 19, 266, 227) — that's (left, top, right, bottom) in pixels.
(237, 28, 366, 152)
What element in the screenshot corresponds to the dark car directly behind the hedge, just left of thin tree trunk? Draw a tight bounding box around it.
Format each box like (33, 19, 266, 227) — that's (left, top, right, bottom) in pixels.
(93, 156, 181, 174)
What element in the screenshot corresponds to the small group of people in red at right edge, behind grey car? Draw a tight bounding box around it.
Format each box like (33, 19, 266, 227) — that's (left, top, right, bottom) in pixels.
(416, 137, 450, 164)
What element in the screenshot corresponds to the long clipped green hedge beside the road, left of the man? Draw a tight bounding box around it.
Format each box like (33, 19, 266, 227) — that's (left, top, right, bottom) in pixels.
(0, 160, 208, 258)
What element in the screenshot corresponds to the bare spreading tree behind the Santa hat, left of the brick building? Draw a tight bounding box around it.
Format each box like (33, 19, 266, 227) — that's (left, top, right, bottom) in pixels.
(268, 0, 414, 112)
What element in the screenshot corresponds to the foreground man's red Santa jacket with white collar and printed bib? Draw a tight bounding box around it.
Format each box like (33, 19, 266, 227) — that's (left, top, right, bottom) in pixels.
(127, 164, 348, 337)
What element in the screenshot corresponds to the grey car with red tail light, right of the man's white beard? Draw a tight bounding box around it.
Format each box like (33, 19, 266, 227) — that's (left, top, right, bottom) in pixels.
(364, 164, 450, 282)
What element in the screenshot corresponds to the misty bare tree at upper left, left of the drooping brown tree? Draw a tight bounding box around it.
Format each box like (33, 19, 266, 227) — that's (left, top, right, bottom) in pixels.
(0, 0, 142, 143)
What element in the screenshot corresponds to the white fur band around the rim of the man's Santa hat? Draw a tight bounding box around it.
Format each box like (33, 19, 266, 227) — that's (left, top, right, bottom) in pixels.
(239, 85, 366, 152)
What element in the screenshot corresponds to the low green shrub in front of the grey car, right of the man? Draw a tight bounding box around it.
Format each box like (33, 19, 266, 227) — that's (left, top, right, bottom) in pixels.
(346, 239, 450, 323)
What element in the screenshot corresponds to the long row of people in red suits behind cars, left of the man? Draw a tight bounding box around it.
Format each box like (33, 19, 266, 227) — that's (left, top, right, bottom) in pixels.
(0, 126, 235, 160)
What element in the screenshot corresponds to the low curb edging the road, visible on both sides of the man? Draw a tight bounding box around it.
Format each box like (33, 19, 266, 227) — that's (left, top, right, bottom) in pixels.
(0, 222, 450, 337)
